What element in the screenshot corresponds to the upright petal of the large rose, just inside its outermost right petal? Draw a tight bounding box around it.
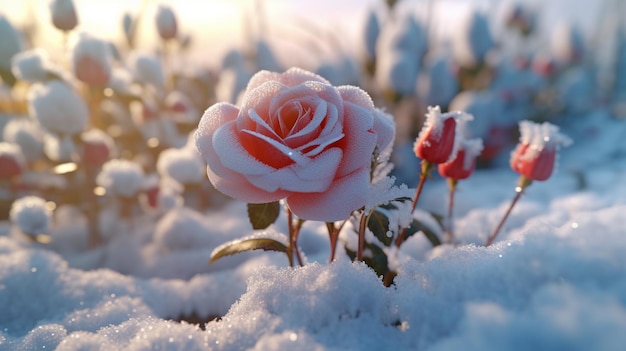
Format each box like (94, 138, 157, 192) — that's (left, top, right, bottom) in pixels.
(338, 102, 376, 177)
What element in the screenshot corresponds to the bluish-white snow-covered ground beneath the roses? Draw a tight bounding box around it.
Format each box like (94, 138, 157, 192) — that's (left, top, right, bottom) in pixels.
(0, 110, 626, 350)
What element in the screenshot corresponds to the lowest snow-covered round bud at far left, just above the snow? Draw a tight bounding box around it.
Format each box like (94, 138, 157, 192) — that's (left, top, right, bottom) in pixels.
(9, 196, 53, 244)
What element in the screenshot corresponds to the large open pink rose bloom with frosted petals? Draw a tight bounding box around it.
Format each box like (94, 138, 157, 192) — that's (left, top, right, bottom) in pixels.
(195, 68, 394, 222)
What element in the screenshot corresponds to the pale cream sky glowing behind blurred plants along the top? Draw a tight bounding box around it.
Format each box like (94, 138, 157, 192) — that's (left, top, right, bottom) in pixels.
(0, 0, 608, 69)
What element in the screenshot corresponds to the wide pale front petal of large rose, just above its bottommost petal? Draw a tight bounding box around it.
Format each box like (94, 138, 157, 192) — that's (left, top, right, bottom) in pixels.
(247, 148, 342, 193)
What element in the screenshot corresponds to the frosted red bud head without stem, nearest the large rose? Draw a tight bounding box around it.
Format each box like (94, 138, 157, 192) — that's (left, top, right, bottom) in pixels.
(413, 106, 472, 163)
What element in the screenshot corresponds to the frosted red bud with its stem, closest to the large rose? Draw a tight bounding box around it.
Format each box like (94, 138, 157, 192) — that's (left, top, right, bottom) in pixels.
(396, 106, 473, 247)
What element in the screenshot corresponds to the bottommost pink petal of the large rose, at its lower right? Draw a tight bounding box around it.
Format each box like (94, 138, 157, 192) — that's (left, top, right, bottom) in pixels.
(287, 167, 370, 222)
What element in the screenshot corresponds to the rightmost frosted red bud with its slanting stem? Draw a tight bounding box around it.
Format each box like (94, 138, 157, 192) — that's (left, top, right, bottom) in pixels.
(485, 121, 572, 246)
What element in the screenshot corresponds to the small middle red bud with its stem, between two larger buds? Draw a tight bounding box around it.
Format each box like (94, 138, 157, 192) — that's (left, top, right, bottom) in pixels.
(437, 135, 483, 243)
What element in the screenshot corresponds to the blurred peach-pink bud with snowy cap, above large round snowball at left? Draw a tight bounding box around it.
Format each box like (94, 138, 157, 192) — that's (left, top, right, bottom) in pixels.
(72, 33, 111, 86)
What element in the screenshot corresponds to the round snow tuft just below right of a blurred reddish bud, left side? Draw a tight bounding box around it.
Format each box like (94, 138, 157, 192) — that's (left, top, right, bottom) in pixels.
(96, 159, 144, 197)
